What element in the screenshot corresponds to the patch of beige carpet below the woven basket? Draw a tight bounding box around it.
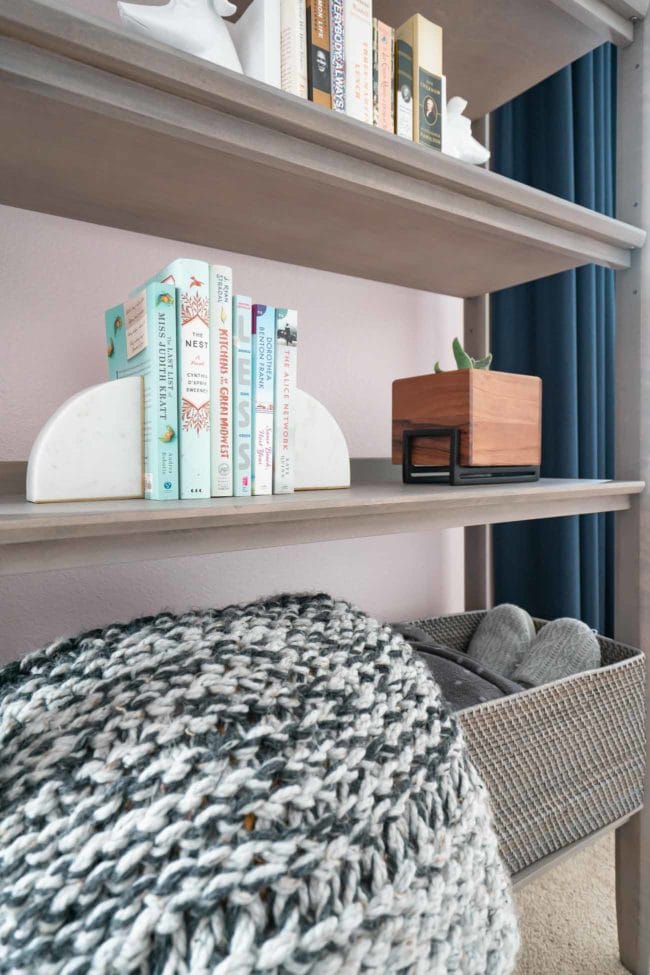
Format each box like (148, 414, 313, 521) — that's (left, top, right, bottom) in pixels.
(516, 833, 626, 975)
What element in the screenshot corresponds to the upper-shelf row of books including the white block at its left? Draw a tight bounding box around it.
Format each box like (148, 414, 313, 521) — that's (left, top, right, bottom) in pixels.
(231, 0, 446, 149)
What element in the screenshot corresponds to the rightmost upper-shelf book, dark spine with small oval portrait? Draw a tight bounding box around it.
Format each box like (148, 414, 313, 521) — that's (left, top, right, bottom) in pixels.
(397, 14, 444, 149)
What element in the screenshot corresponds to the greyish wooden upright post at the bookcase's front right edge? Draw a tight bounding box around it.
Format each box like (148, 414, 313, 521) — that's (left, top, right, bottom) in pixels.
(616, 21, 650, 975)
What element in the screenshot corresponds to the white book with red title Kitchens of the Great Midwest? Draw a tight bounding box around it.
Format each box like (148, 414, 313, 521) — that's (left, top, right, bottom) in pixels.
(210, 264, 233, 498)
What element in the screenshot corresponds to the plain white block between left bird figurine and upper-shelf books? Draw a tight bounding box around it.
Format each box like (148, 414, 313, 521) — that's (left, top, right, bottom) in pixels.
(228, 0, 282, 88)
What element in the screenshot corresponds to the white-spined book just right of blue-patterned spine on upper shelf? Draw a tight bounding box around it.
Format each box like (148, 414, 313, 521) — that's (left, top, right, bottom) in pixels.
(344, 0, 373, 125)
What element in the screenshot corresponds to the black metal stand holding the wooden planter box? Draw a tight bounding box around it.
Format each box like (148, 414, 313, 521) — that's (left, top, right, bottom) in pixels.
(402, 427, 539, 485)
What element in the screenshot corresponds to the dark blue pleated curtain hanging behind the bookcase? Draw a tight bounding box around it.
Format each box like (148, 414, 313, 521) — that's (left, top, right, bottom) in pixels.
(492, 45, 616, 634)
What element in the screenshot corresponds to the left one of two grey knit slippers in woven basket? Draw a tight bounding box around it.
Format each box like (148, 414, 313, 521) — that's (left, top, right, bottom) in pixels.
(467, 603, 535, 677)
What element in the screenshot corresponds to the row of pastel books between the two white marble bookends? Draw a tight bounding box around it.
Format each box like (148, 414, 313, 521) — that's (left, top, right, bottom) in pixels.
(105, 258, 298, 501)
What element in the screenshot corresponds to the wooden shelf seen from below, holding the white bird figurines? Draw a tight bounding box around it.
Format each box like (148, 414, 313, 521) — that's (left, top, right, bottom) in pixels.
(0, 0, 645, 297)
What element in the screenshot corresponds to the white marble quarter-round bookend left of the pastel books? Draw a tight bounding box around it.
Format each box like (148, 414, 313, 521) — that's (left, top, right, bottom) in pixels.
(27, 376, 144, 501)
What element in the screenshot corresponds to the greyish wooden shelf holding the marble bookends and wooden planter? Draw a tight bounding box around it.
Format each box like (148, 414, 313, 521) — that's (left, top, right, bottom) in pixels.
(0, 460, 644, 575)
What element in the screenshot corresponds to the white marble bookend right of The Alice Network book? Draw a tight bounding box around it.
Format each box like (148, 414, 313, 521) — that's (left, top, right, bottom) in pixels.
(295, 389, 350, 491)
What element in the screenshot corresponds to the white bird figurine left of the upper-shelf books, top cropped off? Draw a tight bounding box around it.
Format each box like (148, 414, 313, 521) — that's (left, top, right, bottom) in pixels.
(117, 0, 242, 74)
